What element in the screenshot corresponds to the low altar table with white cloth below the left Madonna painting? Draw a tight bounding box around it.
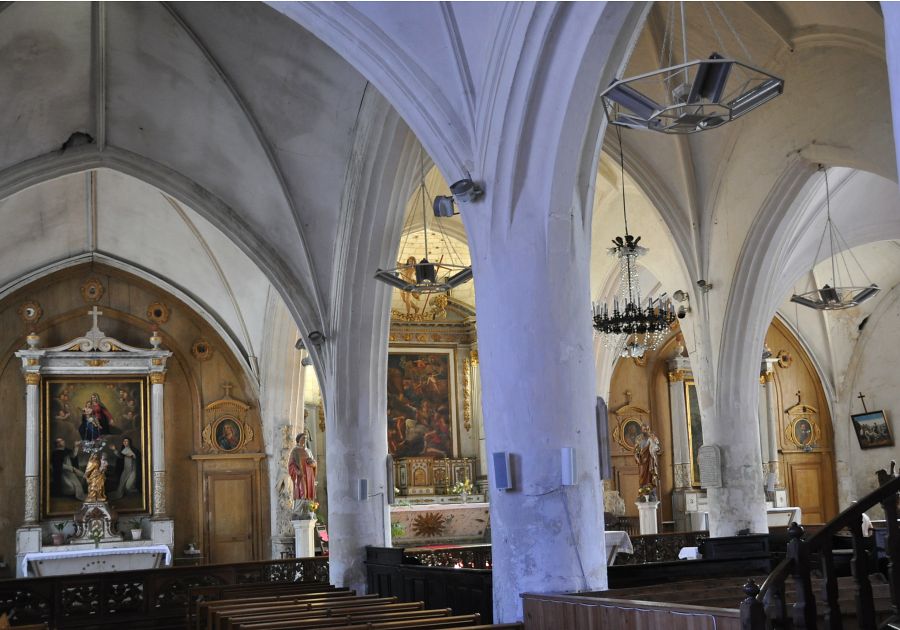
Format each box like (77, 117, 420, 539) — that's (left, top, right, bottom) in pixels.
(22, 545, 172, 577)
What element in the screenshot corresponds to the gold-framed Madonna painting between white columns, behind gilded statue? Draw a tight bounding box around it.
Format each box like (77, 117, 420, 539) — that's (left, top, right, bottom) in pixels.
(41, 376, 150, 517)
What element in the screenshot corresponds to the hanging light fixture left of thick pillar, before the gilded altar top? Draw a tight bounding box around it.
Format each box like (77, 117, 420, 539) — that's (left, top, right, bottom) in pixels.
(375, 150, 472, 293)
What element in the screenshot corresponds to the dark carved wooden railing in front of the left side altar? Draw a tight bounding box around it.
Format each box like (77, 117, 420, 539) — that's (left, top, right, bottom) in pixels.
(0, 557, 328, 629)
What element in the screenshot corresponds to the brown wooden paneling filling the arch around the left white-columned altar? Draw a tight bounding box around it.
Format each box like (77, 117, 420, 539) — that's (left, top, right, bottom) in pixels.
(0, 264, 269, 561)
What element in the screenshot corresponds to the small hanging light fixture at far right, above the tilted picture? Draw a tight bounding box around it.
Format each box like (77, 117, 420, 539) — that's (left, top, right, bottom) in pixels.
(791, 164, 881, 311)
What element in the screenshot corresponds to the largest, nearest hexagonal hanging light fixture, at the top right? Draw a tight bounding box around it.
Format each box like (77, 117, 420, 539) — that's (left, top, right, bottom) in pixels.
(600, 2, 784, 134)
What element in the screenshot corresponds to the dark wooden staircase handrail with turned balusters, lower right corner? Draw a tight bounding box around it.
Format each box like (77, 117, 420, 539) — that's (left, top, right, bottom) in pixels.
(741, 470, 900, 630)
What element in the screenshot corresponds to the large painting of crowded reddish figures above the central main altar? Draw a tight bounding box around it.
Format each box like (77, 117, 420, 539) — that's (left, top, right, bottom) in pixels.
(387, 348, 456, 458)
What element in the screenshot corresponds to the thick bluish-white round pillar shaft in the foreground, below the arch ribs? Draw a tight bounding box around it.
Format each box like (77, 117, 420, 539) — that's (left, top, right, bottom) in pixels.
(475, 223, 606, 622)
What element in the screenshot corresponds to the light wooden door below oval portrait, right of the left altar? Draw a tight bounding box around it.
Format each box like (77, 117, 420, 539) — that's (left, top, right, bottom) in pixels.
(204, 472, 256, 564)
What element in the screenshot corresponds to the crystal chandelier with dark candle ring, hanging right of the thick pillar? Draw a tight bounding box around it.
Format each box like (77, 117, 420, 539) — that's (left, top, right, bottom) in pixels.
(593, 129, 675, 359)
